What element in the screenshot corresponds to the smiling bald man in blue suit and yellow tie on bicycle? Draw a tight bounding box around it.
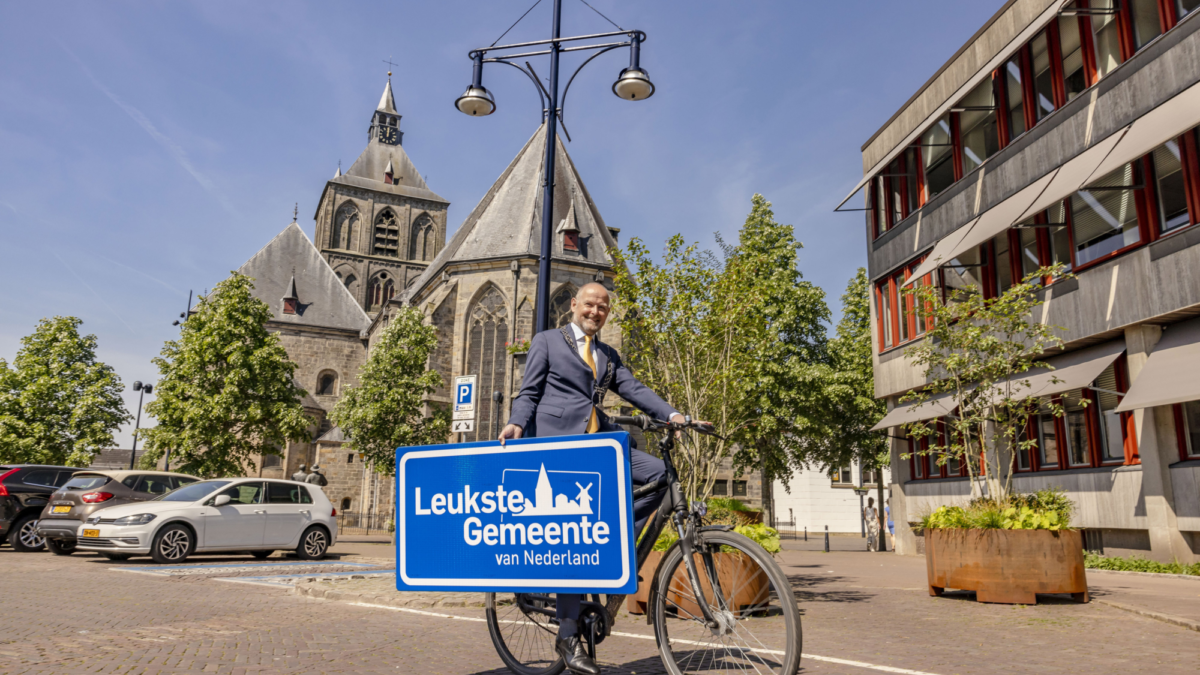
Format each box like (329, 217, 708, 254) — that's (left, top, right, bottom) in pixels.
(499, 283, 684, 675)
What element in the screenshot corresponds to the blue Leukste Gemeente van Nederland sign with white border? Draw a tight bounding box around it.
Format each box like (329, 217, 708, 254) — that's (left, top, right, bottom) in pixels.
(396, 431, 637, 595)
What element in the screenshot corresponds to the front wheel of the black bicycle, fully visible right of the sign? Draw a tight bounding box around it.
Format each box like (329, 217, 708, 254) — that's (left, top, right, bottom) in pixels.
(652, 531, 802, 675)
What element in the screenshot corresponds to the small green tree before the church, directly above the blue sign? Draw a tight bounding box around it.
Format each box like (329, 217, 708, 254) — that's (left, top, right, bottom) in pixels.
(330, 307, 450, 474)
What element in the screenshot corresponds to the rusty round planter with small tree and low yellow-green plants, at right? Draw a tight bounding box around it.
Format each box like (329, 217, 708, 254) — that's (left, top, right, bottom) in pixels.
(901, 265, 1087, 604)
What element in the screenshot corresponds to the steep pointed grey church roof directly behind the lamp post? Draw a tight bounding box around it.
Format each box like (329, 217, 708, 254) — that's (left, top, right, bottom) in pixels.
(400, 124, 617, 301)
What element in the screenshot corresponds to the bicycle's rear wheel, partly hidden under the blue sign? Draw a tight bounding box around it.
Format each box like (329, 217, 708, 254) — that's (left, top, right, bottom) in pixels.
(485, 593, 566, 675)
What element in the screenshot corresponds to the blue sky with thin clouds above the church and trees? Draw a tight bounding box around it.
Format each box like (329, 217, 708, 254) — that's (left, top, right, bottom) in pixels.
(0, 0, 1002, 447)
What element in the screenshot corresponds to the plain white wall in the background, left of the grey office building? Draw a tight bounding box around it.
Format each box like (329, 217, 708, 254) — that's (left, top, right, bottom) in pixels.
(772, 458, 892, 536)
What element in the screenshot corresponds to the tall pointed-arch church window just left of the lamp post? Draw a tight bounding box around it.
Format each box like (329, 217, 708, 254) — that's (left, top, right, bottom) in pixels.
(466, 286, 509, 441)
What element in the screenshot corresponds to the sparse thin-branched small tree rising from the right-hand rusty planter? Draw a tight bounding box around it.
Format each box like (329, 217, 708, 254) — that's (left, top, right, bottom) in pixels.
(901, 264, 1070, 502)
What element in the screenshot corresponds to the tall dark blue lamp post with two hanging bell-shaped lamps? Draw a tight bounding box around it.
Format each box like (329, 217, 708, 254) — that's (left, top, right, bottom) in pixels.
(455, 0, 654, 333)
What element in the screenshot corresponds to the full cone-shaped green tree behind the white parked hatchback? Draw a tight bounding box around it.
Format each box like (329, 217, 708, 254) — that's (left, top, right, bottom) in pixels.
(142, 273, 312, 477)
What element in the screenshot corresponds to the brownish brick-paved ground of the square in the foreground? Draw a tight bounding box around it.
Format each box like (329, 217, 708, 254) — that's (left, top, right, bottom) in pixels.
(0, 548, 1200, 675)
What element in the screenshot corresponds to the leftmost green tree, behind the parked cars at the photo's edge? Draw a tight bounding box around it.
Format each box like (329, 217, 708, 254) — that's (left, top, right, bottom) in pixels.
(0, 316, 133, 466)
